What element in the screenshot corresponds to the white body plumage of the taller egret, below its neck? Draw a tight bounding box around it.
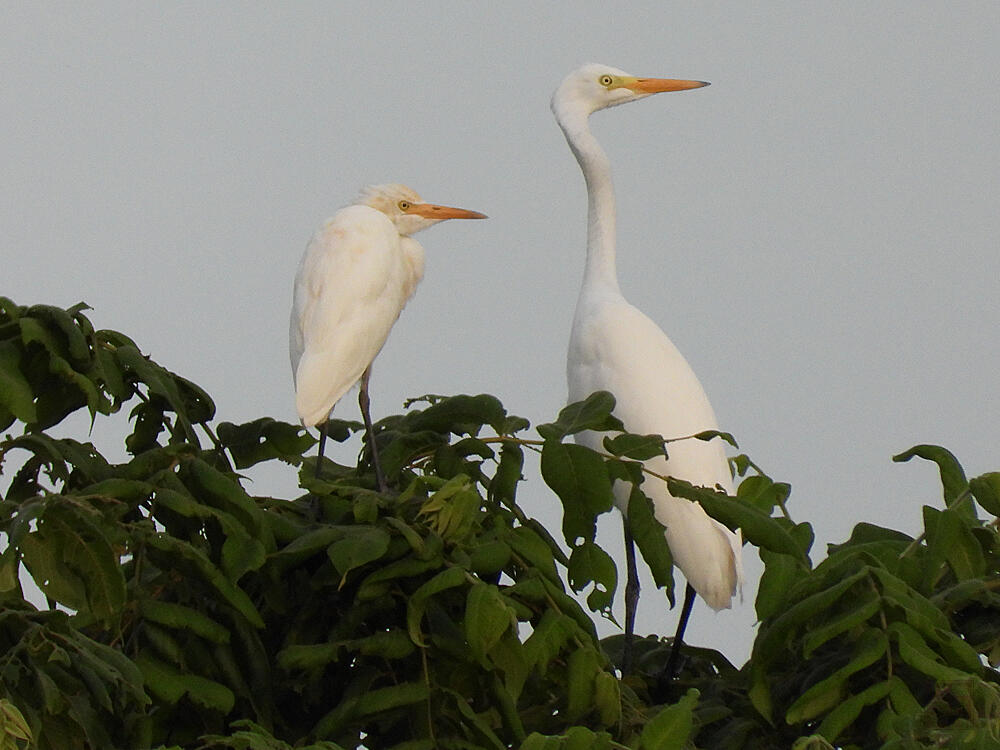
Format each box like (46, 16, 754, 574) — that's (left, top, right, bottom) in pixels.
(567, 294, 741, 610)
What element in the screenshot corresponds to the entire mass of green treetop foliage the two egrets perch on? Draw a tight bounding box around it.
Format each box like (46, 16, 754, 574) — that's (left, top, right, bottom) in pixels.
(0, 298, 1000, 750)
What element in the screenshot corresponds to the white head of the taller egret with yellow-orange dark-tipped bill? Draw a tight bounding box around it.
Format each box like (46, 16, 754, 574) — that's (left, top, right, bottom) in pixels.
(552, 63, 708, 120)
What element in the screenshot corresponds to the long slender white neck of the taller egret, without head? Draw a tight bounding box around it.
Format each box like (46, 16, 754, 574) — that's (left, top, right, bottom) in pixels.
(556, 106, 621, 295)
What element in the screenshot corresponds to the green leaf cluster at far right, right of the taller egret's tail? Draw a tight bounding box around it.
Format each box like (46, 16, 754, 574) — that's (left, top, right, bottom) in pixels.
(728, 446, 1000, 749)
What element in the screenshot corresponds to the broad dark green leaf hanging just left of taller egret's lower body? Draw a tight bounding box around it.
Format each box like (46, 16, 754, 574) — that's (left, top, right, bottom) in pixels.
(541, 440, 612, 546)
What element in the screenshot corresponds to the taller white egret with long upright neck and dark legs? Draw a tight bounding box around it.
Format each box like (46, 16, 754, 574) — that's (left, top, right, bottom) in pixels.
(552, 63, 742, 673)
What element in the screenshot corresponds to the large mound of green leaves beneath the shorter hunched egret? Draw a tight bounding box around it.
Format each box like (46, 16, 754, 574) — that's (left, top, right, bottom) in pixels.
(0, 300, 652, 748)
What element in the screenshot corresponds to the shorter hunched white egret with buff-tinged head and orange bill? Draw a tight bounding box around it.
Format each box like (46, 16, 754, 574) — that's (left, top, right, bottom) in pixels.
(288, 185, 486, 491)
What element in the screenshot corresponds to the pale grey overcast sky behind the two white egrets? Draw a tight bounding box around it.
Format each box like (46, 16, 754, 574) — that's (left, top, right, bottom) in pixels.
(0, 0, 1000, 663)
